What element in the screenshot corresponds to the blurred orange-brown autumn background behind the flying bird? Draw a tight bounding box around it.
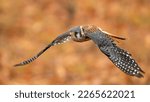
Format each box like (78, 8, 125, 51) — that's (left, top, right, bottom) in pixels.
(0, 0, 150, 85)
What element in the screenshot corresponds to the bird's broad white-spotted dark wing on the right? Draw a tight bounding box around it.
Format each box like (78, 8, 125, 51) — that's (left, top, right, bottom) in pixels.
(87, 32, 144, 78)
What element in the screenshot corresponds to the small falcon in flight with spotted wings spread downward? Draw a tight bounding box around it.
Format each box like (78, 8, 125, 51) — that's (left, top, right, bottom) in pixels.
(14, 25, 144, 78)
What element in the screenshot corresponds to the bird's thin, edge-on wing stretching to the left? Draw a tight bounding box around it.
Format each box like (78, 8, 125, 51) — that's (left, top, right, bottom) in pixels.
(14, 33, 71, 66)
